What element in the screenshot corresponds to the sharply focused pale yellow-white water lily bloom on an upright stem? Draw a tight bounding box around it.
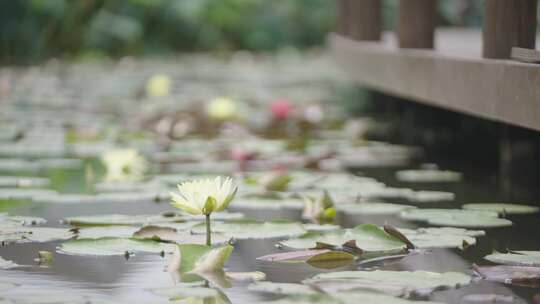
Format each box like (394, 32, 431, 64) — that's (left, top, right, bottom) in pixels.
(171, 176, 238, 215)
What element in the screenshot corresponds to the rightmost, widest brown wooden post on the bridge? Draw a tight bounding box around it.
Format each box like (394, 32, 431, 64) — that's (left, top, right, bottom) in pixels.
(483, 0, 538, 59)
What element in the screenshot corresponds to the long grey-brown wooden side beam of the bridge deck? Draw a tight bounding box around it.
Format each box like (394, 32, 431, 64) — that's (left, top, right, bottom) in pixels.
(329, 34, 540, 131)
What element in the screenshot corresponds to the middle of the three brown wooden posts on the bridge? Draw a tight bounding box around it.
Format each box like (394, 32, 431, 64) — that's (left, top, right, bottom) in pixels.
(396, 0, 437, 49)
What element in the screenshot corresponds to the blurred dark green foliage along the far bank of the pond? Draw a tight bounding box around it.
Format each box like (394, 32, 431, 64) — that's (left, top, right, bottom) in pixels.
(0, 0, 336, 62)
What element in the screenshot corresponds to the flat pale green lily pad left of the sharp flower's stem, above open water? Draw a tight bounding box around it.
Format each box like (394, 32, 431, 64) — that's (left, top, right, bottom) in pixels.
(58, 237, 170, 256)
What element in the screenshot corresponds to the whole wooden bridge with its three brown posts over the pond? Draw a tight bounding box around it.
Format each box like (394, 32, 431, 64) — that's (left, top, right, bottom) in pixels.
(330, 0, 540, 131)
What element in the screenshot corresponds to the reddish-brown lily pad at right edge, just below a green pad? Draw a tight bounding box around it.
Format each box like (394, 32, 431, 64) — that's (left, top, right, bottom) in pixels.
(473, 265, 540, 288)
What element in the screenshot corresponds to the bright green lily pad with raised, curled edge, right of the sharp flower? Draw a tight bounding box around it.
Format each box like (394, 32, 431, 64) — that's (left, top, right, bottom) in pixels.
(281, 224, 406, 253)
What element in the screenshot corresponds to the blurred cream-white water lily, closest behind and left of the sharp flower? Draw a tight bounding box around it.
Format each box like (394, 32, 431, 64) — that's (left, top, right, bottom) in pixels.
(101, 149, 148, 182)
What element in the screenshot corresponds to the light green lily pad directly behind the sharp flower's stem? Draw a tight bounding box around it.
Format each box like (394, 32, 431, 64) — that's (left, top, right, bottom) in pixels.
(192, 220, 306, 239)
